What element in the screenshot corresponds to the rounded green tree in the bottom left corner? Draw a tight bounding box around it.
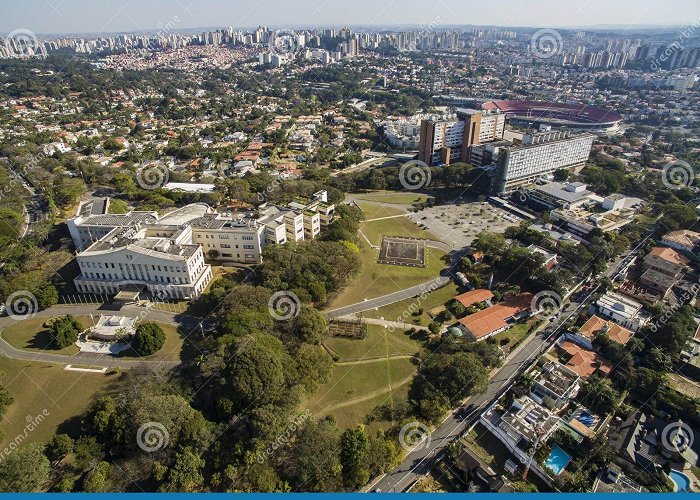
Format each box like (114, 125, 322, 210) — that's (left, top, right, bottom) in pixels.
(0, 443, 51, 493)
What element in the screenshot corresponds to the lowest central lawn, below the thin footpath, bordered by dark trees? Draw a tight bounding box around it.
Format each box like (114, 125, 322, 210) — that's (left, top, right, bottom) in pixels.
(307, 359, 416, 416)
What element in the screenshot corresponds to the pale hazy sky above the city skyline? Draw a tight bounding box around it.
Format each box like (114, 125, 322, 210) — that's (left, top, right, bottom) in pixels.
(0, 0, 700, 33)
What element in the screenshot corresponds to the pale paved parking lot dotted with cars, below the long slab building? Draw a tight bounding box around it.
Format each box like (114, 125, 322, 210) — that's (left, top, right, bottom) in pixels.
(408, 201, 521, 248)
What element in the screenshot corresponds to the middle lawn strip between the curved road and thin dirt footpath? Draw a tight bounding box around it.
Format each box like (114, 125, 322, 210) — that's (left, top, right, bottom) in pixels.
(323, 325, 421, 362)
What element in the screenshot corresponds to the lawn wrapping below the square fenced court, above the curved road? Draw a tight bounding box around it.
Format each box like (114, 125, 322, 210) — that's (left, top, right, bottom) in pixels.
(329, 243, 447, 309)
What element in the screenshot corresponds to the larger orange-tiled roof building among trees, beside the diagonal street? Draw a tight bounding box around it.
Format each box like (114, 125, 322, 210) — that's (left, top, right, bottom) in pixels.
(459, 293, 532, 342)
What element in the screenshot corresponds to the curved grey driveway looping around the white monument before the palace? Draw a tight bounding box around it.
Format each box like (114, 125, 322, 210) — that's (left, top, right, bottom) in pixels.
(0, 305, 210, 368)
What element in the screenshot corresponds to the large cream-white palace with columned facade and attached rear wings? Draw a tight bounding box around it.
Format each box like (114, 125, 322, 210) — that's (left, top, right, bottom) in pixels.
(67, 191, 335, 299)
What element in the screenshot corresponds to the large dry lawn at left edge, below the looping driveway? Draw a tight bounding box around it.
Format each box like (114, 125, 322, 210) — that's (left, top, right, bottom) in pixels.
(0, 358, 120, 449)
